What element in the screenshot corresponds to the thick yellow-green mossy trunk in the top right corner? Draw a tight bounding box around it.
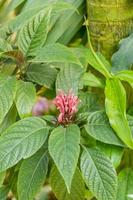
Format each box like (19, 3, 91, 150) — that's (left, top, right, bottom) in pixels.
(87, 0, 133, 59)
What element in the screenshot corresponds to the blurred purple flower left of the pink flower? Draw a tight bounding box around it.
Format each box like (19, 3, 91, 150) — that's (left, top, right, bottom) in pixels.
(32, 97, 49, 116)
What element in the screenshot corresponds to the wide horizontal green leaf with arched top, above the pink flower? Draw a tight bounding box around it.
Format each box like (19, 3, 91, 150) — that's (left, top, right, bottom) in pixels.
(32, 43, 82, 66)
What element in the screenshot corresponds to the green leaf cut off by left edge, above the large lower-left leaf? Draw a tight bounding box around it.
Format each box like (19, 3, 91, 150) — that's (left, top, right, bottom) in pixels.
(0, 75, 16, 123)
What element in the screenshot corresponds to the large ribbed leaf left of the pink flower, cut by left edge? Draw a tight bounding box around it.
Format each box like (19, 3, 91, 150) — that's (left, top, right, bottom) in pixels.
(0, 117, 48, 172)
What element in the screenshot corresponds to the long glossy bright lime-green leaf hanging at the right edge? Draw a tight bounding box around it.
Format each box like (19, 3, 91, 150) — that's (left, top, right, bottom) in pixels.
(105, 78, 133, 148)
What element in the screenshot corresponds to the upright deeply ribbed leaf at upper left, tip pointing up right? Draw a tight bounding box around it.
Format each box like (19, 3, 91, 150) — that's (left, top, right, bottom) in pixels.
(18, 9, 51, 56)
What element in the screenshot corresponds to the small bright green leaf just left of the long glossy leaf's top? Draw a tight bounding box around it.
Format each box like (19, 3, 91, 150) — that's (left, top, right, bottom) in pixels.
(81, 72, 105, 88)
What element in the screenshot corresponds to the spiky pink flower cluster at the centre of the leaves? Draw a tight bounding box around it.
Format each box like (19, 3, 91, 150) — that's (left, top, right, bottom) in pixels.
(54, 91, 79, 124)
